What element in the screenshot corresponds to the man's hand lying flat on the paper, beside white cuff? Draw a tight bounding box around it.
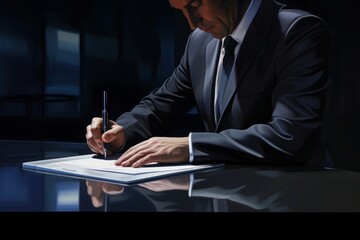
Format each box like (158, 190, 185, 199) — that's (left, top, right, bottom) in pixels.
(115, 137, 189, 167)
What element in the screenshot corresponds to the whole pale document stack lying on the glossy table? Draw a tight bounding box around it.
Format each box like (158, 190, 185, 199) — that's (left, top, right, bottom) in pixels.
(23, 154, 223, 184)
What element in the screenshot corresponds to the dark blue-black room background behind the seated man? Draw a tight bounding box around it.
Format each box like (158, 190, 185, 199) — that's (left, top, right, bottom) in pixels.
(0, 0, 360, 170)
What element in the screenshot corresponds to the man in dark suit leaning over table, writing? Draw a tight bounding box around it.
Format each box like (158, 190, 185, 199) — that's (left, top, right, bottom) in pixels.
(86, 0, 328, 167)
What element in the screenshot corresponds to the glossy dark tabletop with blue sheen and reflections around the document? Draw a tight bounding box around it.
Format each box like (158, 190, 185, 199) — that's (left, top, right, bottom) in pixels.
(0, 140, 360, 212)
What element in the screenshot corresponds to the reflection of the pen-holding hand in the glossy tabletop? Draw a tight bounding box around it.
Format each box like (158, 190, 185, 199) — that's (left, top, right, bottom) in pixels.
(86, 181, 124, 208)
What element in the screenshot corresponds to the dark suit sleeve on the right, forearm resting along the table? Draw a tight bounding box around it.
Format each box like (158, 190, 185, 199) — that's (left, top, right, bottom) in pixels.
(191, 17, 328, 164)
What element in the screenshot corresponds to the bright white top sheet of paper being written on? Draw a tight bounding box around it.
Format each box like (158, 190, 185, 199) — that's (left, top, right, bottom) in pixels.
(56, 158, 208, 175)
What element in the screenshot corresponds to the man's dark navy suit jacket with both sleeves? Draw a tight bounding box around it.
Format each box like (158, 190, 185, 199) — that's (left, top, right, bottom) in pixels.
(117, 0, 328, 167)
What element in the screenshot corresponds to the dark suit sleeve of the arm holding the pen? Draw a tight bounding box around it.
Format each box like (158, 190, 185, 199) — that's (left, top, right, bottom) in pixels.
(116, 32, 195, 150)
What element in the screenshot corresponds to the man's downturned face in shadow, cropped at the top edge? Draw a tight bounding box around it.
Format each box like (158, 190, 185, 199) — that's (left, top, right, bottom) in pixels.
(169, 0, 239, 39)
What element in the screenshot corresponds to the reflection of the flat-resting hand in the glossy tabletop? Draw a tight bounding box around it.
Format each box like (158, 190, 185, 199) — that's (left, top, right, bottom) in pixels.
(139, 175, 190, 192)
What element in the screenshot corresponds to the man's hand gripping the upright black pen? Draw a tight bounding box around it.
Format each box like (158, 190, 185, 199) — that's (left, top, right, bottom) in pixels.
(86, 117, 125, 154)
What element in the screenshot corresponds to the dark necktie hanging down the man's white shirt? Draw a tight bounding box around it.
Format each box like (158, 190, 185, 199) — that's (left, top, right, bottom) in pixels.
(216, 36, 237, 121)
